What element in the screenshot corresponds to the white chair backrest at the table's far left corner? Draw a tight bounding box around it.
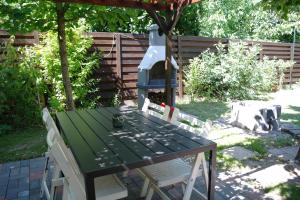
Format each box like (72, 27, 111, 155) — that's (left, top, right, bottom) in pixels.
(42, 108, 61, 147)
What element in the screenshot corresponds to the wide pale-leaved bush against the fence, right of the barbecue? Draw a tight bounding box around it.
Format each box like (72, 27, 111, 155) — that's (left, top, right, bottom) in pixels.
(185, 43, 292, 100)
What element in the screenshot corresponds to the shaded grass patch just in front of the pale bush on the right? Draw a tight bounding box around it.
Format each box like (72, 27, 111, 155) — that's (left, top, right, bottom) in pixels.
(176, 101, 229, 121)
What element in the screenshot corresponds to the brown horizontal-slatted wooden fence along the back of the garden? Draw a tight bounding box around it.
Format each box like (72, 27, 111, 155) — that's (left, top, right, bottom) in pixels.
(0, 30, 300, 100)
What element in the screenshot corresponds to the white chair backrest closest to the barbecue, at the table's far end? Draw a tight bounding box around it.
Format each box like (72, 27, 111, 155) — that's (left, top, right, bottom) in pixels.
(142, 98, 170, 121)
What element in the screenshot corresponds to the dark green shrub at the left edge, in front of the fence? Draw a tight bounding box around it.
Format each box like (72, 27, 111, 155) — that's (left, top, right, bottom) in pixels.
(0, 37, 40, 133)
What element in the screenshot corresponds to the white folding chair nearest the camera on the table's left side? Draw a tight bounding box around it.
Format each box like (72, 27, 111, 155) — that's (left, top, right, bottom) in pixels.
(51, 135, 128, 200)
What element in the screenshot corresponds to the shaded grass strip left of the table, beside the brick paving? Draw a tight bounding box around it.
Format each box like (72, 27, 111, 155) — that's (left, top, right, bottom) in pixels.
(0, 127, 47, 163)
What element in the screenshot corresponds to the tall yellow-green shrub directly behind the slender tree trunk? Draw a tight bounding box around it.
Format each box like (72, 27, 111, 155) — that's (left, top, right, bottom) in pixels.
(27, 22, 101, 111)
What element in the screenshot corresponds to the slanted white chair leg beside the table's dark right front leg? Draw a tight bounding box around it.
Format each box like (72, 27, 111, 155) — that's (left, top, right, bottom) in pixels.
(183, 153, 202, 200)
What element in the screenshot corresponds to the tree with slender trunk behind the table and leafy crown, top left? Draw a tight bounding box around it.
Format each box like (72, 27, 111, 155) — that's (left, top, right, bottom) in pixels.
(0, 0, 137, 110)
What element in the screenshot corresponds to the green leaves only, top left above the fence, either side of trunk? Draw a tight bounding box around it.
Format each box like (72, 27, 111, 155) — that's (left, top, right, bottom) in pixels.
(0, 0, 138, 33)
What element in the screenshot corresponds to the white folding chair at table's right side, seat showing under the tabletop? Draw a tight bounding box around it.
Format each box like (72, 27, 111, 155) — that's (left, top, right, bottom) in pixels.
(138, 108, 208, 200)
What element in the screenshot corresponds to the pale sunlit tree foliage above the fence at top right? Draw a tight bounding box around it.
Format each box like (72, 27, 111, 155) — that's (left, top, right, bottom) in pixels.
(178, 0, 300, 41)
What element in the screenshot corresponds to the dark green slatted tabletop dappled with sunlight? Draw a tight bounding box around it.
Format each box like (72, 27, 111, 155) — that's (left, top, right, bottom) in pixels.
(56, 107, 216, 177)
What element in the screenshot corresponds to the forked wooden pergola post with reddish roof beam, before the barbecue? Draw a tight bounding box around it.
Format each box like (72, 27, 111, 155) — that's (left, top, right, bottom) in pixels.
(54, 0, 200, 106)
